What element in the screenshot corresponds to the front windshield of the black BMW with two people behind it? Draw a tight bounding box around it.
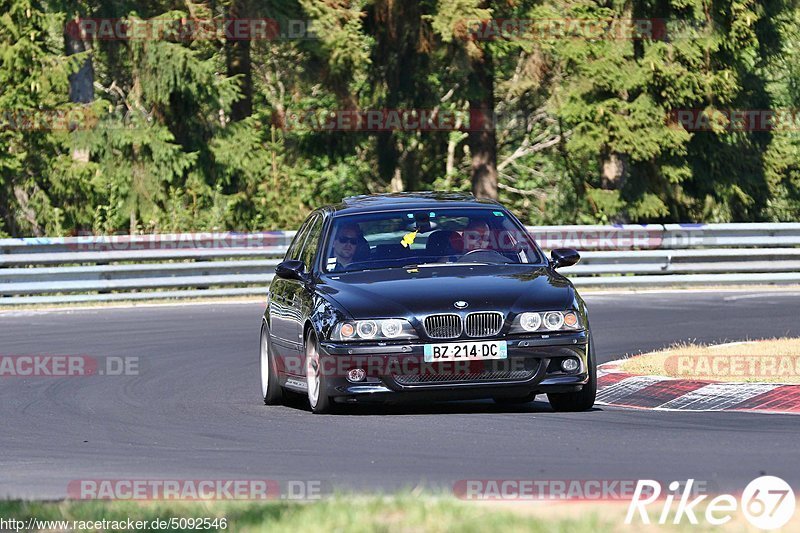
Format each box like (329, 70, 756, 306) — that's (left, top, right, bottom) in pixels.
(323, 208, 543, 272)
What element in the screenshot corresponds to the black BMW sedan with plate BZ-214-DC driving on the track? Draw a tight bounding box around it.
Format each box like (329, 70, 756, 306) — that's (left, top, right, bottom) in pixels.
(260, 193, 597, 413)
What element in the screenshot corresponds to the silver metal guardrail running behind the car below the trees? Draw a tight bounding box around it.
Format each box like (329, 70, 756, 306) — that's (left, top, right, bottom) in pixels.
(0, 223, 800, 306)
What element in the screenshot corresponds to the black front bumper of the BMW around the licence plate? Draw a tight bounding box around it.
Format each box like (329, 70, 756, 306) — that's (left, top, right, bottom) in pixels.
(320, 331, 589, 401)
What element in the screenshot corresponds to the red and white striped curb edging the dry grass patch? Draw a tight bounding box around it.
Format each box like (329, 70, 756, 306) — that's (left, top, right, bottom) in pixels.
(595, 360, 800, 414)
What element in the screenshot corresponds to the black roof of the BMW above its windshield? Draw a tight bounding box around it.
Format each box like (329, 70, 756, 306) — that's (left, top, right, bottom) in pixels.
(330, 191, 500, 216)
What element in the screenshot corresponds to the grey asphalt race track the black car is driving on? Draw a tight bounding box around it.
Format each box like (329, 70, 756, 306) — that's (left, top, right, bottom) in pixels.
(0, 289, 800, 498)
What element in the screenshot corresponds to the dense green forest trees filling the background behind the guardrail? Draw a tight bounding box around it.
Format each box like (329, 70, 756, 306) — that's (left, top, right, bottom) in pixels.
(0, 0, 800, 235)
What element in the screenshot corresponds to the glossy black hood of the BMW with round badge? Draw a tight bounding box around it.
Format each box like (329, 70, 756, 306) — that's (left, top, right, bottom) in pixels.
(318, 265, 574, 319)
